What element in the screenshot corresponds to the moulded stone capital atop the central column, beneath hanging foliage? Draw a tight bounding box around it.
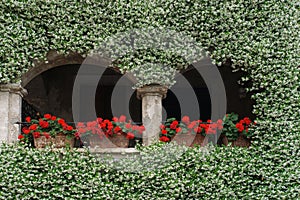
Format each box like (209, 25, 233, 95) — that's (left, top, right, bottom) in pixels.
(137, 85, 168, 99)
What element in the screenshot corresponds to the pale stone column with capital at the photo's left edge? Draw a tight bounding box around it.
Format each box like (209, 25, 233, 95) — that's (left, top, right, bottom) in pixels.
(0, 84, 27, 143)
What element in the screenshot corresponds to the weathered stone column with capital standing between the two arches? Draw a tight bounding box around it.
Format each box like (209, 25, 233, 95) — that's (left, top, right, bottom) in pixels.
(137, 85, 168, 146)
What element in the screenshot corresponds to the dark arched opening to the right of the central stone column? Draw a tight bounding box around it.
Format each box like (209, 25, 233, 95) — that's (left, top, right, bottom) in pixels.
(163, 65, 254, 120)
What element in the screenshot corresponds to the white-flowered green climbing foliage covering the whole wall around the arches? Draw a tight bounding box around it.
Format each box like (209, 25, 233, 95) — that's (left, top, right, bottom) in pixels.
(0, 0, 300, 199)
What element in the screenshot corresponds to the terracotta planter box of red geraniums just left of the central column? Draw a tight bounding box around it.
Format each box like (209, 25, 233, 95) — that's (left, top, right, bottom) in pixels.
(89, 134, 129, 148)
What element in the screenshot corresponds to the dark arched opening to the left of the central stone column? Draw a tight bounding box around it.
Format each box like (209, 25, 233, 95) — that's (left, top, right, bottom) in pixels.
(22, 65, 141, 122)
